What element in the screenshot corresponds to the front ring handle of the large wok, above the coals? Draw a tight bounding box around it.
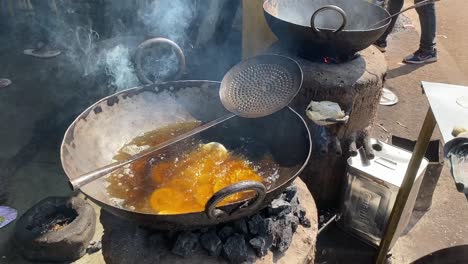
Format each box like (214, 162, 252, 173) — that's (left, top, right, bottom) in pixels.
(205, 181, 266, 219)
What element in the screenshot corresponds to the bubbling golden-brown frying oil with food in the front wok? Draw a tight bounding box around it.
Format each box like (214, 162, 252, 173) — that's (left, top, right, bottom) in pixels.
(107, 122, 279, 214)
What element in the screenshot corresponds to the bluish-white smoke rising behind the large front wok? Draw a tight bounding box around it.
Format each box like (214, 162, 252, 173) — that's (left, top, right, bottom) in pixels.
(5, 0, 198, 95)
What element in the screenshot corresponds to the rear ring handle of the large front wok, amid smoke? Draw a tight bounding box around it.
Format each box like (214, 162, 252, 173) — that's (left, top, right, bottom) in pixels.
(135, 38, 186, 84)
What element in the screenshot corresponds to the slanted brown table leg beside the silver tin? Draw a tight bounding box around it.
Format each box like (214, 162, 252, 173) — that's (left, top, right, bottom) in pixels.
(376, 109, 436, 264)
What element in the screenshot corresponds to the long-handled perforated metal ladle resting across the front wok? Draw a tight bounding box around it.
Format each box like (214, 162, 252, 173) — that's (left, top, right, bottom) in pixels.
(70, 54, 302, 190)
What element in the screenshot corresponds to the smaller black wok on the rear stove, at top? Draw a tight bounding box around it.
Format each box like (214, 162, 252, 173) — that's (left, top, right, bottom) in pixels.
(263, 0, 390, 57)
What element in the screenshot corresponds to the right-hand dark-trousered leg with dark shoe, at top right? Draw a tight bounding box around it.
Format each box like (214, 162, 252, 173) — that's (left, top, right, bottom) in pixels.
(403, 0, 437, 64)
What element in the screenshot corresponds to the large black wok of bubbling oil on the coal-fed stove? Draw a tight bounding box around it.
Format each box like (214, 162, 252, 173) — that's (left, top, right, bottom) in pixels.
(61, 81, 312, 229)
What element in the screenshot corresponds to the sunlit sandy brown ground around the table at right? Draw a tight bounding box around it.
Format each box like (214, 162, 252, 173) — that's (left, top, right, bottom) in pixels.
(374, 0, 468, 263)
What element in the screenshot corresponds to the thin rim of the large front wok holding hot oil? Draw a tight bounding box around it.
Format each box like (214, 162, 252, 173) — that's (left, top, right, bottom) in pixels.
(60, 80, 312, 217)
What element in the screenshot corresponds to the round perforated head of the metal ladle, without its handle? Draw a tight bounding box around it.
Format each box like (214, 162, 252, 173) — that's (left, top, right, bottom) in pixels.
(219, 54, 302, 118)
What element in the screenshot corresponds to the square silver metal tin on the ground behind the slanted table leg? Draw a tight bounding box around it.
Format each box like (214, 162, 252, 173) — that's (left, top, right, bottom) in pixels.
(340, 139, 429, 248)
